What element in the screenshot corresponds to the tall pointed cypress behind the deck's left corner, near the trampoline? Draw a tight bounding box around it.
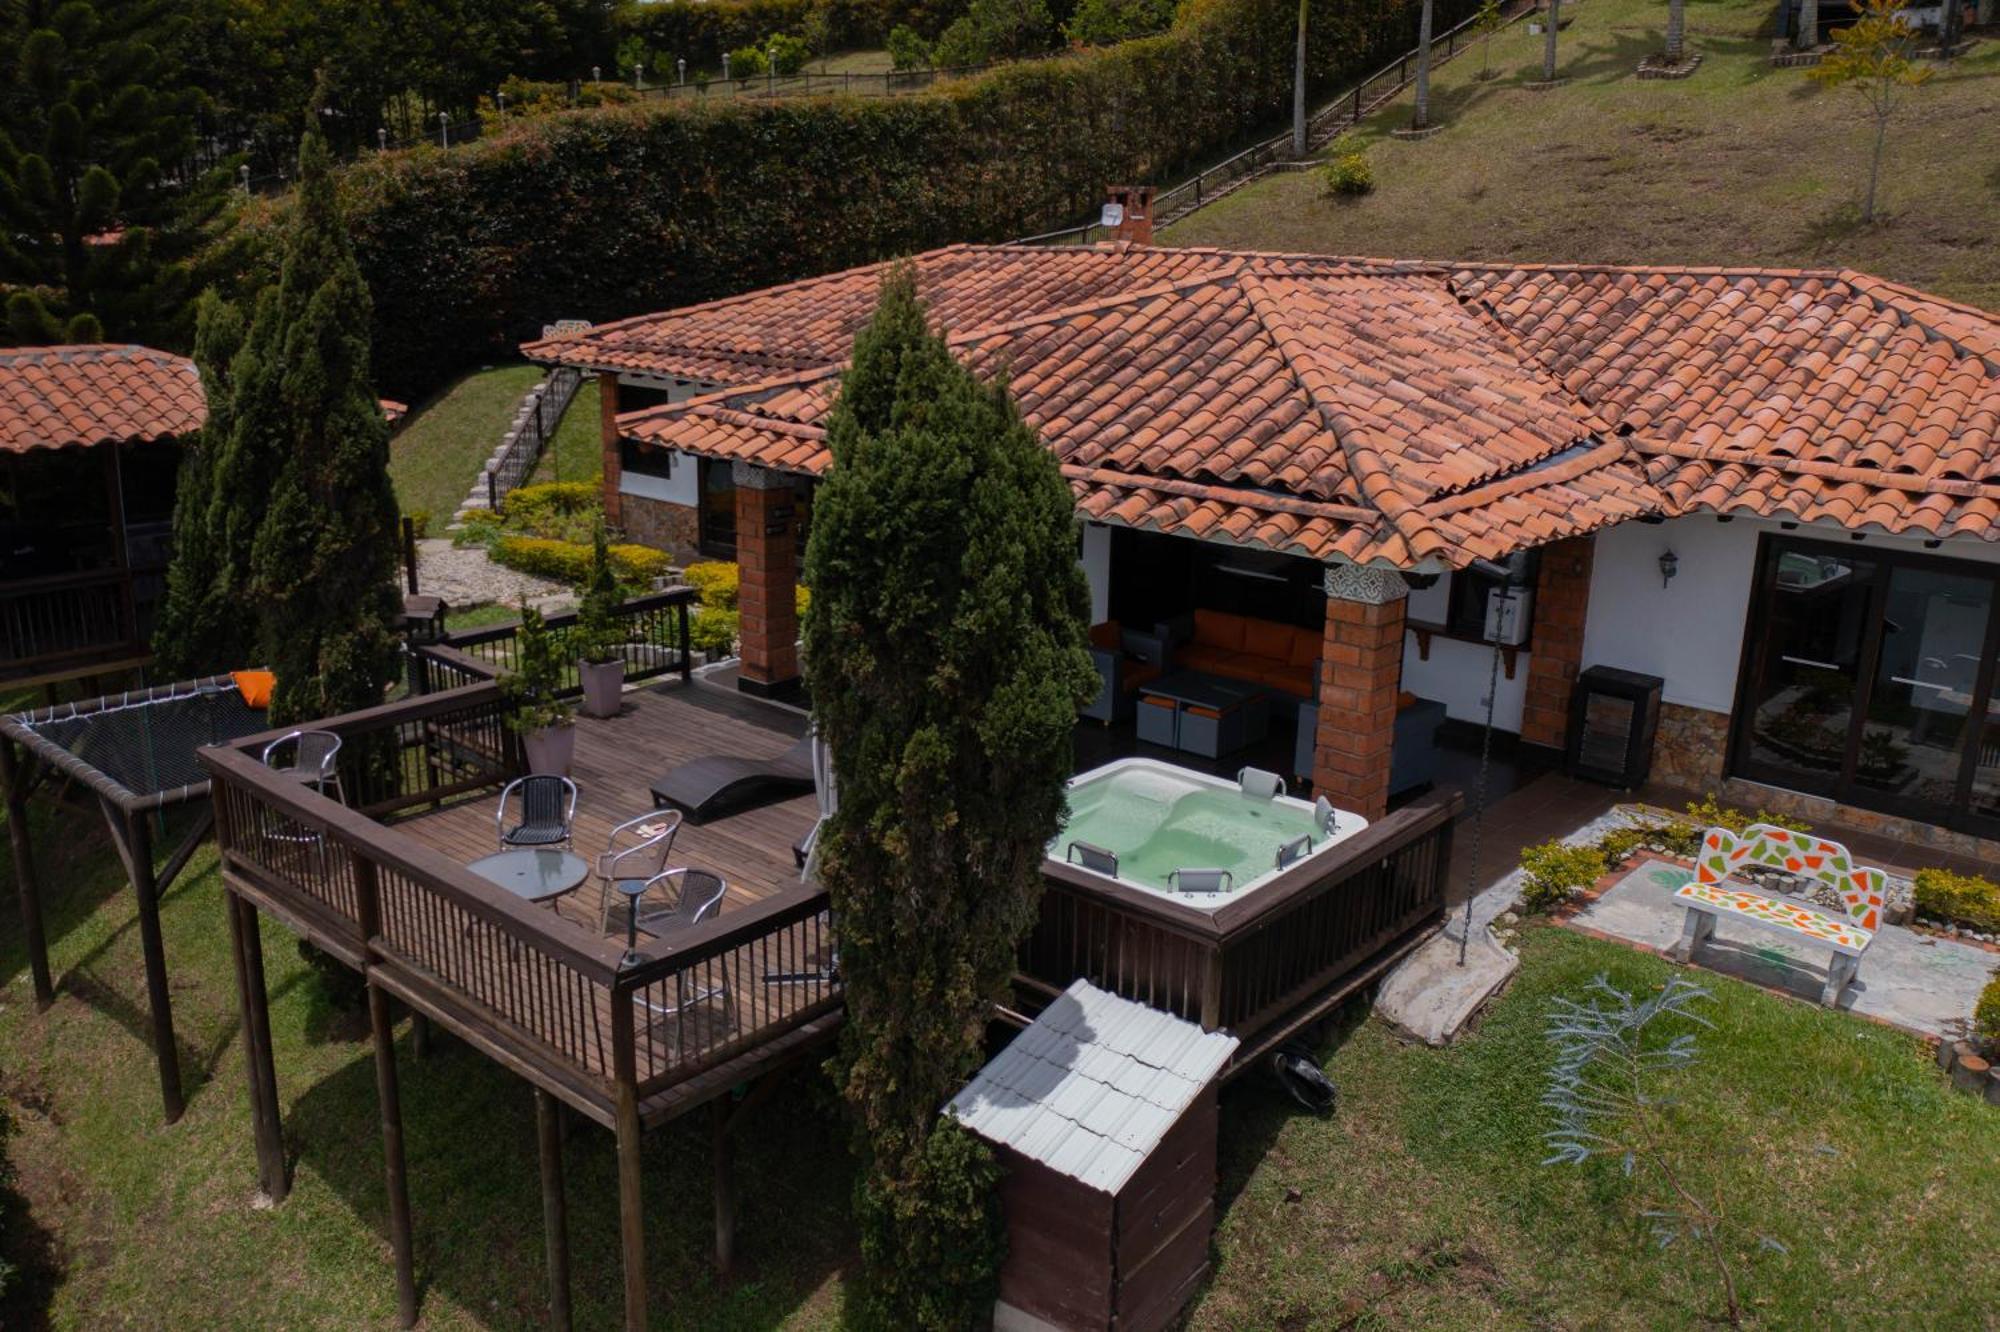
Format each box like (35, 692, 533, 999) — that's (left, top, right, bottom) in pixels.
(242, 116, 396, 722)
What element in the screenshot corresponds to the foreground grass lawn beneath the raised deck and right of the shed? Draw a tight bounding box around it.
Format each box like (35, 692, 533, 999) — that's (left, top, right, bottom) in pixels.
(0, 780, 2000, 1330)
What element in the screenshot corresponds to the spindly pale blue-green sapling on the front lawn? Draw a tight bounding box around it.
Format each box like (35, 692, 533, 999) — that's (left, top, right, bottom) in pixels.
(1542, 974, 1786, 1326)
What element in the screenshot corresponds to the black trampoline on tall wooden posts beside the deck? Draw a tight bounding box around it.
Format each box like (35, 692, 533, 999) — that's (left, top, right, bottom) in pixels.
(0, 676, 270, 1124)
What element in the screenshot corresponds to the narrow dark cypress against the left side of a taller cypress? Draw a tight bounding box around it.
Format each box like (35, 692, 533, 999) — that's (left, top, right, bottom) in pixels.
(152, 290, 252, 676)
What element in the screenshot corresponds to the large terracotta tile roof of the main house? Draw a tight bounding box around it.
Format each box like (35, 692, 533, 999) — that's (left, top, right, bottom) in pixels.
(580, 246, 2000, 568)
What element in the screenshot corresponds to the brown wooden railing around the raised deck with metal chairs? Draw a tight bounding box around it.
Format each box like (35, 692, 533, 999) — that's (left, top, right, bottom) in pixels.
(202, 682, 840, 1122)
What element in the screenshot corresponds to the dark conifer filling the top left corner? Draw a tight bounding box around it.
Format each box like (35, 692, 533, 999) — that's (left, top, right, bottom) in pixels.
(0, 0, 228, 344)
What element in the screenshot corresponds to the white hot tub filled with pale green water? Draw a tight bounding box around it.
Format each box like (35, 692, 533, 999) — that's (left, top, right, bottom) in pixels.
(1048, 758, 1368, 906)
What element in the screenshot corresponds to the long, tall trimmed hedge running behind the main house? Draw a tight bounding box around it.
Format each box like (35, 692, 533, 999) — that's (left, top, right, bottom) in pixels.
(250, 0, 1474, 398)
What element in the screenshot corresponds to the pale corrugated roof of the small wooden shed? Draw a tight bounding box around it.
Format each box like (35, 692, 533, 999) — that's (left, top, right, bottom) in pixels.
(946, 980, 1238, 1194)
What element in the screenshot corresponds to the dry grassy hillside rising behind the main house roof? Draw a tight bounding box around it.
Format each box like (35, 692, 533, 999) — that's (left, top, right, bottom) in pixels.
(1162, 0, 2000, 308)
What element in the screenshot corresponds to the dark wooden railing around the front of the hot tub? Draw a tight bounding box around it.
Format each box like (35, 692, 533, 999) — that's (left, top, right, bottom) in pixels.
(1020, 798, 1456, 1034)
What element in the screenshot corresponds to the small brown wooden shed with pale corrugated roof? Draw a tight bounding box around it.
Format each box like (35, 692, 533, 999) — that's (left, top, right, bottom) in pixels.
(948, 980, 1236, 1332)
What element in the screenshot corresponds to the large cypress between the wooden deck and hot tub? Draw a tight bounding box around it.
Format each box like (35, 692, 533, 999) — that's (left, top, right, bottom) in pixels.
(804, 266, 1096, 1328)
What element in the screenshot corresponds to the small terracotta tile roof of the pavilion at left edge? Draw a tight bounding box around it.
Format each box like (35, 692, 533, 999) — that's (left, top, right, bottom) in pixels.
(0, 344, 208, 454)
